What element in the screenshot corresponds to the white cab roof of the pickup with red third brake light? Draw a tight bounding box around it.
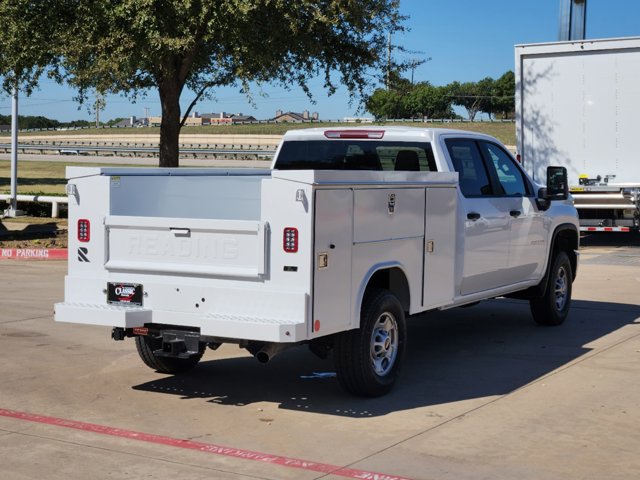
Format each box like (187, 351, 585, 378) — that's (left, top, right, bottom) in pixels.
(283, 125, 495, 142)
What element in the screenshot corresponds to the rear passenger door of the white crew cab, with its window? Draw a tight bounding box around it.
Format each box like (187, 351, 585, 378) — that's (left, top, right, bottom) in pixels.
(445, 138, 511, 295)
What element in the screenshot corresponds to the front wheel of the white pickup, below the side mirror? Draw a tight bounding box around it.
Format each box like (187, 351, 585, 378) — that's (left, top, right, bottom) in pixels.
(529, 252, 573, 325)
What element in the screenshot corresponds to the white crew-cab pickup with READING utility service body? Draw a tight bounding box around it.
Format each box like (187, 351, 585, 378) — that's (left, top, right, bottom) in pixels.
(55, 127, 579, 396)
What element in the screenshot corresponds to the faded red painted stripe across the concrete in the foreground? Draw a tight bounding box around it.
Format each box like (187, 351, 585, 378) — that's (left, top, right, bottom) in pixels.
(0, 408, 410, 480)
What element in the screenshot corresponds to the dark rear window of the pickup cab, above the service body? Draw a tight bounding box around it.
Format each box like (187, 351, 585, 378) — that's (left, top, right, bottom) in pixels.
(275, 140, 437, 172)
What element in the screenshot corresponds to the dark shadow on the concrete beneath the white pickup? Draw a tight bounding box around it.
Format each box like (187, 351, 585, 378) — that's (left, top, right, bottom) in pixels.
(133, 299, 640, 418)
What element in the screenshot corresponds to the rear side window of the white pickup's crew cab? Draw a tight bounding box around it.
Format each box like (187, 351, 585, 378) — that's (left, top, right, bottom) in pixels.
(445, 140, 492, 197)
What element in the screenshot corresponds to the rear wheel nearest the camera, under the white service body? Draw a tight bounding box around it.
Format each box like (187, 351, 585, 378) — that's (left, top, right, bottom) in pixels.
(334, 289, 406, 397)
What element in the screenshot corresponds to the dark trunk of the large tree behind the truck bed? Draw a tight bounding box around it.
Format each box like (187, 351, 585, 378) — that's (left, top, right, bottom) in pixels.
(158, 80, 182, 167)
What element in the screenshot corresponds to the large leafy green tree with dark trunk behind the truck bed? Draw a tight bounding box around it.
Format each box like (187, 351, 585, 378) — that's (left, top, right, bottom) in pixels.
(0, 0, 402, 167)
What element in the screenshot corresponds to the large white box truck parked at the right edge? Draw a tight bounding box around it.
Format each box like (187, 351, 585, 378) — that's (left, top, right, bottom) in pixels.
(515, 38, 640, 232)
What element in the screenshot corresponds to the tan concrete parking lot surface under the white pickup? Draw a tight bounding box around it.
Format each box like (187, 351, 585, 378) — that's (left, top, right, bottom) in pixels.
(0, 237, 640, 480)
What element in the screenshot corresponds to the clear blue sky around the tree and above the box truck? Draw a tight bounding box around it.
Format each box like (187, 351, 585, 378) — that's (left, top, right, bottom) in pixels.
(0, 0, 640, 121)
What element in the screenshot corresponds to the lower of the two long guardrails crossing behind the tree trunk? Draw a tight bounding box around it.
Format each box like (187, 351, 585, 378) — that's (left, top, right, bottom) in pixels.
(0, 143, 275, 159)
